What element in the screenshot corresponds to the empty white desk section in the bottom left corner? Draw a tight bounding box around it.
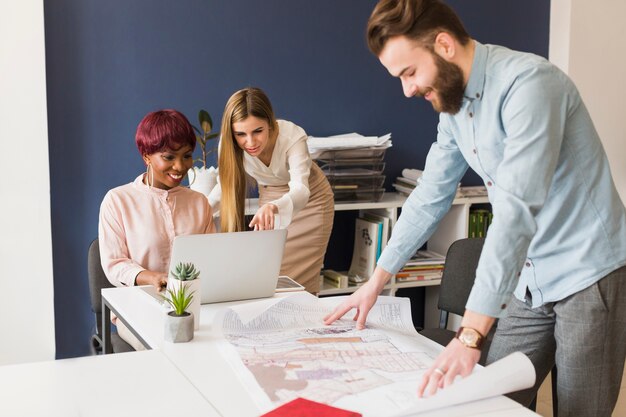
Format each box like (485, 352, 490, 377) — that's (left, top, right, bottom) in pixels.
(0, 350, 220, 417)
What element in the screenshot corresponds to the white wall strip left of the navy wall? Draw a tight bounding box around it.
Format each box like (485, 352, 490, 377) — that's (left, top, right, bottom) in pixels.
(0, 0, 55, 365)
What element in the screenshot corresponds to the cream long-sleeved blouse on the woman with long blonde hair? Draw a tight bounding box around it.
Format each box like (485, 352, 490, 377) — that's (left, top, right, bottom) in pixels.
(209, 120, 312, 229)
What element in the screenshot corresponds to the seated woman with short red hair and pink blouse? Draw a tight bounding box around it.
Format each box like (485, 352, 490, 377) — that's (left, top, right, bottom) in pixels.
(98, 110, 215, 349)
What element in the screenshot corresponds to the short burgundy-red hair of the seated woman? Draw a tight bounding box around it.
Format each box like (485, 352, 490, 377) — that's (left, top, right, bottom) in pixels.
(135, 109, 196, 156)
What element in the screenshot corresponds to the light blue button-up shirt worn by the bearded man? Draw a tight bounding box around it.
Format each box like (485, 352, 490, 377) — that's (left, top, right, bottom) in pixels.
(378, 42, 626, 317)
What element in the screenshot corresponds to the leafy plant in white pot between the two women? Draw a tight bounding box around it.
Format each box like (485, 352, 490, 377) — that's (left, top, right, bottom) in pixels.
(189, 109, 219, 196)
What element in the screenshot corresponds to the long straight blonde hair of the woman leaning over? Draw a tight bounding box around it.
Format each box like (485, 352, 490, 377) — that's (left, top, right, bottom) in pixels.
(218, 87, 278, 232)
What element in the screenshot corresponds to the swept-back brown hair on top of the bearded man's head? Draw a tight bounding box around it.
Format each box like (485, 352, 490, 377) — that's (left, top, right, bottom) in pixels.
(367, 0, 470, 56)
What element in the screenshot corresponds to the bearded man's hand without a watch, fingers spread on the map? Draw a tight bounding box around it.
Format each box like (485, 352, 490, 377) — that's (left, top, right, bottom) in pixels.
(324, 267, 391, 330)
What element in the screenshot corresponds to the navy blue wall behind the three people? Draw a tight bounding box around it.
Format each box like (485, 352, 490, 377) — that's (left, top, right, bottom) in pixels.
(44, 0, 550, 358)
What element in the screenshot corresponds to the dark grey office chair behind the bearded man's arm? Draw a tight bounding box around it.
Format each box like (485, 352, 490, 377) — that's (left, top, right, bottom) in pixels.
(419, 238, 558, 417)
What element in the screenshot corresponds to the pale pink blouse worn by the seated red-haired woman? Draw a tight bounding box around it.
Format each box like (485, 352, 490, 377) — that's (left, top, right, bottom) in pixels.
(98, 174, 215, 287)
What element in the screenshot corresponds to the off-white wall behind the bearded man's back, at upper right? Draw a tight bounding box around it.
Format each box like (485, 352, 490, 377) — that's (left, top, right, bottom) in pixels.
(550, 0, 626, 203)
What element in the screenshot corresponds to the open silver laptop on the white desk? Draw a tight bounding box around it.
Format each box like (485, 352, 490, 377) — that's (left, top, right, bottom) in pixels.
(165, 229, 287, 304)
